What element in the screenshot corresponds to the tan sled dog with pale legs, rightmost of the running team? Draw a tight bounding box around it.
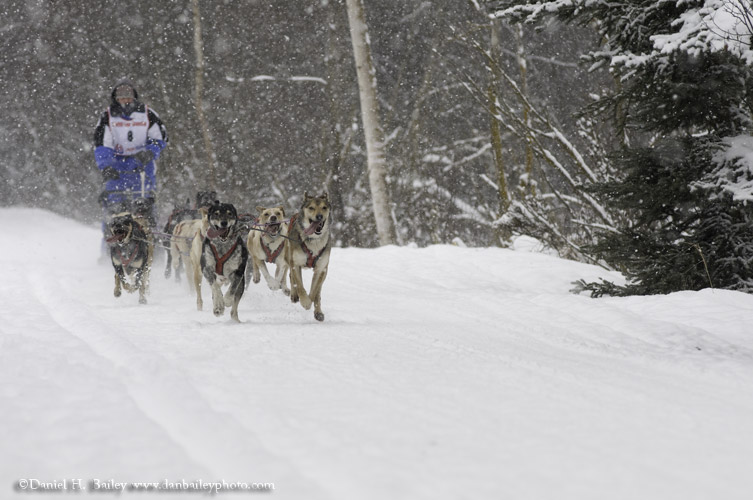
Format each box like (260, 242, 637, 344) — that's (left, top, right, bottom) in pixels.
(285, 193, 332, 321)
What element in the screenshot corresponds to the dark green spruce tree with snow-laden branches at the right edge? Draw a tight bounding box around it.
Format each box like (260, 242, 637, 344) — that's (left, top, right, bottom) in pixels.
(488, 0, 753, 295)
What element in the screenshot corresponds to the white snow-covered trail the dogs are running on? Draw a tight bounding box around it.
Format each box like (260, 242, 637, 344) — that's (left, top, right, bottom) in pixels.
(0, 208, 753, 500)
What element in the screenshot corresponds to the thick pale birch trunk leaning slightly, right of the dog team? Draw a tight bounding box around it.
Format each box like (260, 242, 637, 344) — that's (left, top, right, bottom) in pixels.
(345, 0, 395, 245)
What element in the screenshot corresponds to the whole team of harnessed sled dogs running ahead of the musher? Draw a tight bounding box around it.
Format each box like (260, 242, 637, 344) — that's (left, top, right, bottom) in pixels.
(106, 192, 332, 321)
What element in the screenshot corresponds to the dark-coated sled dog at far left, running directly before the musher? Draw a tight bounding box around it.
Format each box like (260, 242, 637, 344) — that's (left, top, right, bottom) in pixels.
(106, 212, 153, 304)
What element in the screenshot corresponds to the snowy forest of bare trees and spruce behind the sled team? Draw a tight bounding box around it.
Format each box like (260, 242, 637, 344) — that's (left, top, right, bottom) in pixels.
(0, 0, 753, 295)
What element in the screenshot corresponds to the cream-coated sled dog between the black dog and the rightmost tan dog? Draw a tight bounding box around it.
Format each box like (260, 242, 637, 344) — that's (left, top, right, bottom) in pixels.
(246, 207, 290, 295)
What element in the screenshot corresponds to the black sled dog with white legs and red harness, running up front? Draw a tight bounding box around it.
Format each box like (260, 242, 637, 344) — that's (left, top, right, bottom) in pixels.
(196, 203, 248, 321)
